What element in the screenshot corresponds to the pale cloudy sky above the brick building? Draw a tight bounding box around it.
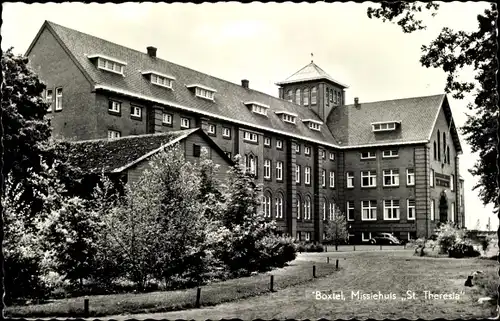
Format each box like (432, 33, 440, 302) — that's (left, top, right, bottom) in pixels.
(1, 2, 498, 230)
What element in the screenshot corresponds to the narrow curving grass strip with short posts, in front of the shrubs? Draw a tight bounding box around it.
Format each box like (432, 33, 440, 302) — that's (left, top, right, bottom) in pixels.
(4, 260, 335, 318)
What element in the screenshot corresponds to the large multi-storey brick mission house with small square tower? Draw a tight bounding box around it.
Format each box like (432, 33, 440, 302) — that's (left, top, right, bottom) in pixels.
(26, 21, 465, 242)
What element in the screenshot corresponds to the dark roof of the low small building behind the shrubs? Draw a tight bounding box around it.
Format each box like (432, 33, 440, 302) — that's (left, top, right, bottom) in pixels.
(64, 128, 232, 174)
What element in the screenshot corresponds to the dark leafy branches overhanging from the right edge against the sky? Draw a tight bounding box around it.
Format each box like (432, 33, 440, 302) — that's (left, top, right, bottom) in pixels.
(367, 1, 500, 212)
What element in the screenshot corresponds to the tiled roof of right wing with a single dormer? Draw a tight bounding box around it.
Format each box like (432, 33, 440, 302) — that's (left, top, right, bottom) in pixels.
(327, 94, 462, 151)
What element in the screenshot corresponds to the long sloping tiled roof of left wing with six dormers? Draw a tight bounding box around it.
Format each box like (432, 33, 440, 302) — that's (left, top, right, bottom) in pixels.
(35, 21, 337, 146)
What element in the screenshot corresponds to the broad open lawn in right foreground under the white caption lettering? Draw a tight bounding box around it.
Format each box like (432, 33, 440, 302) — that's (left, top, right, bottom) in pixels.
(106, 249, 497, 320)
